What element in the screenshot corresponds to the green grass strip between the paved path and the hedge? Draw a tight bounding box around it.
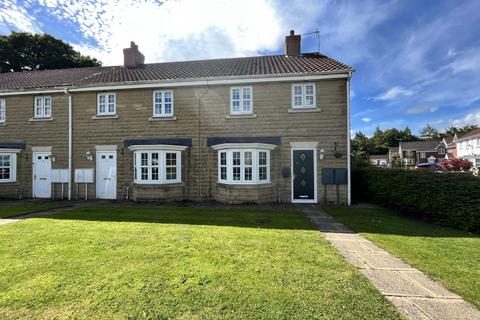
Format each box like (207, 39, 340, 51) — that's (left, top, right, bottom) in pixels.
(327, 208, 480, 307)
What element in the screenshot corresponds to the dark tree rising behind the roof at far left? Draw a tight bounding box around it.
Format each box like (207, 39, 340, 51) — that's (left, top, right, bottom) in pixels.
(0, 32, 101, 72)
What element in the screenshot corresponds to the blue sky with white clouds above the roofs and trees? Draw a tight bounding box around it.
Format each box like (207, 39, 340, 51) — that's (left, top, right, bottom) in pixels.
(0, 0, 480, 134)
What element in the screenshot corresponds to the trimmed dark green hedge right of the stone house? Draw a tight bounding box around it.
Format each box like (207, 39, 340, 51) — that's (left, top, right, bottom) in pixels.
(352, 168, 480, 233)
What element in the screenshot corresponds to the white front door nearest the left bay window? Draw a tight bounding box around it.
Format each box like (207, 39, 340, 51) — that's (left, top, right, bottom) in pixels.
(97, 151, 117, 199)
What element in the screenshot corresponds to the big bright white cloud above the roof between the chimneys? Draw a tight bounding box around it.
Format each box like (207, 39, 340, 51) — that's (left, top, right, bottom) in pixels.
(21, 0, 288, 65)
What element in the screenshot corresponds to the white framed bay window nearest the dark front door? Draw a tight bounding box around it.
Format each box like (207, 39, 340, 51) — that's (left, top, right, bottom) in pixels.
(218, 149, 270, 184)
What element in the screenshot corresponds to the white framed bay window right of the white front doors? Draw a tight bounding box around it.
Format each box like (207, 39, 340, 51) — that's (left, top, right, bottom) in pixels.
(133, 150, 182, 184)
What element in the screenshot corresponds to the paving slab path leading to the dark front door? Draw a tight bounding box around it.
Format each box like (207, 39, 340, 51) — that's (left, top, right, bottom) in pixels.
(304, 207, 480, 320)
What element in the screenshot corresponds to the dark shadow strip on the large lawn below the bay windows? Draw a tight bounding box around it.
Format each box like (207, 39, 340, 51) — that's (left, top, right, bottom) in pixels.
(33, 205, 316, 230)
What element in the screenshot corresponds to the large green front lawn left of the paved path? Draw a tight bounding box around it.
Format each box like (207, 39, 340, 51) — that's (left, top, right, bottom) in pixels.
(0, 206, 400, 319)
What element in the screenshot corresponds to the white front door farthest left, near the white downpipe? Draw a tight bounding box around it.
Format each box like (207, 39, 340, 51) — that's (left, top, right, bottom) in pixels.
(33, 152, 52, 198)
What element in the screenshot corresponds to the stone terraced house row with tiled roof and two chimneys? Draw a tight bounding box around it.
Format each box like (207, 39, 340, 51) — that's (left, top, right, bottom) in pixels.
(0, 31, 354, 203)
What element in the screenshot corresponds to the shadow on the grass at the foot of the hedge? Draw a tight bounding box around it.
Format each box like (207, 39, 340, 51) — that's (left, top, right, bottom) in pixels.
(326, 208, 479, 238)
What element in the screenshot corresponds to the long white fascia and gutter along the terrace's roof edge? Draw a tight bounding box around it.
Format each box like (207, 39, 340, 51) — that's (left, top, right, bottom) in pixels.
(0, 71, 351, 97)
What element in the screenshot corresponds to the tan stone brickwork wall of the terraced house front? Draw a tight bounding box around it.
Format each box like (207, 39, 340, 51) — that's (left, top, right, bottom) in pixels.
(0, 79, 347, 203)
